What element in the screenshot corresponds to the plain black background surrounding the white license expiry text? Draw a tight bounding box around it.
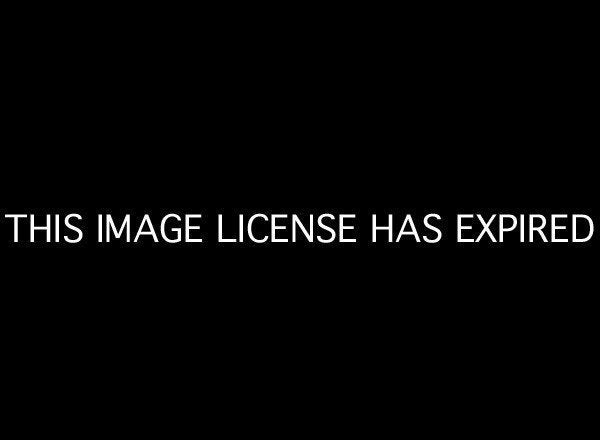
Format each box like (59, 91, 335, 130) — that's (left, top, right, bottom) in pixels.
(1, 5, 598, 433)
